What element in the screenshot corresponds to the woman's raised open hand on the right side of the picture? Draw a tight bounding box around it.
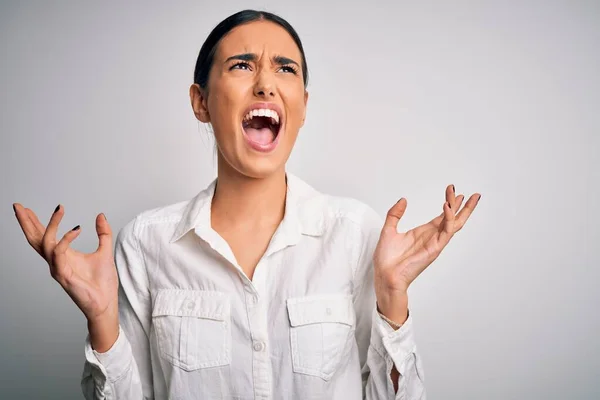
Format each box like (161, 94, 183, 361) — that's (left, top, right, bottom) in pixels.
(373, 185, 481, 322)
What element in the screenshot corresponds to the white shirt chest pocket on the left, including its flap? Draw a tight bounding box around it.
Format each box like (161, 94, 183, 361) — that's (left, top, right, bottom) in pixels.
(152, 289, 231, 371)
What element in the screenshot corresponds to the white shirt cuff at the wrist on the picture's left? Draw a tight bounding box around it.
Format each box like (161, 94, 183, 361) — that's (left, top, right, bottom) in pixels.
(85, 325, 133, 384)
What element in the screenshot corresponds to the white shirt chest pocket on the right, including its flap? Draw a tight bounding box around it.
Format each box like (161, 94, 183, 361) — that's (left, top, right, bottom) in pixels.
(287, 295, 356, 381)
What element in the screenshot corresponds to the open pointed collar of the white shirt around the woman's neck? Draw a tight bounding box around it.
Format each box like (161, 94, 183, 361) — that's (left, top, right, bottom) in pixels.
(170, 172, 324, 245)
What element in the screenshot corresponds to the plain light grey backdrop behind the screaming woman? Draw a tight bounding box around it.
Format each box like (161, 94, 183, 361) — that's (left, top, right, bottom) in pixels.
(0, 0, 600, 400)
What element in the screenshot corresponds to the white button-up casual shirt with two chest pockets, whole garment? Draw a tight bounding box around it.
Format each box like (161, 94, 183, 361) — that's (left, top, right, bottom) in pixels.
(81, 172, 426, 400)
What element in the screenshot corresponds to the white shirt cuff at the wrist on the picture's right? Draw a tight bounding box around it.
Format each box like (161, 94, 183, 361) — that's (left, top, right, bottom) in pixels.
(371, 306, 416, 376)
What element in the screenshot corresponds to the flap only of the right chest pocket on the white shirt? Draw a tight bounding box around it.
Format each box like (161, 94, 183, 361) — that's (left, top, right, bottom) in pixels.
(287, 295, 356, 326)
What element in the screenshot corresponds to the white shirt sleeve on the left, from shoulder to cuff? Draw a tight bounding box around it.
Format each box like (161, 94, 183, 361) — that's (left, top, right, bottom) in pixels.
(81, 217, 154, 400)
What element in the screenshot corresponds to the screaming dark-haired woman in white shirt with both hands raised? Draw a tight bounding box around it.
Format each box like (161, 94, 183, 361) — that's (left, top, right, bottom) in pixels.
(14, 10, 479, 400)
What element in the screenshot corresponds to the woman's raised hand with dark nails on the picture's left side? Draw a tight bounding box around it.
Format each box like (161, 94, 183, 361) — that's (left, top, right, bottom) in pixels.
(13, 203, 119, 328)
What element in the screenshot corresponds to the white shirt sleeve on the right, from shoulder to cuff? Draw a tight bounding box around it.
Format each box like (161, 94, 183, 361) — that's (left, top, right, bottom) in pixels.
(353, 207, 426, 400)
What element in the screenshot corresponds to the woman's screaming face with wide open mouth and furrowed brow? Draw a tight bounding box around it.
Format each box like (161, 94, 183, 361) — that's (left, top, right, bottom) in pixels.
(190, 21, 308, 178)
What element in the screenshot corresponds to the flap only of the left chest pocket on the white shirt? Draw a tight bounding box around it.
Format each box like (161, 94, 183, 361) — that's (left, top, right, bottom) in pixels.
(152, 289, 230, 321)
